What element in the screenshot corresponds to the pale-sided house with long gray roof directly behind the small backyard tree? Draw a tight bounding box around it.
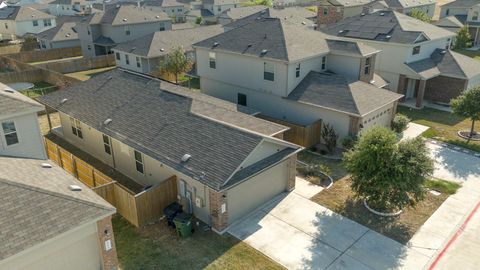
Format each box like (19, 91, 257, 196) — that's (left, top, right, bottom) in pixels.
(112, 25, 223, 74)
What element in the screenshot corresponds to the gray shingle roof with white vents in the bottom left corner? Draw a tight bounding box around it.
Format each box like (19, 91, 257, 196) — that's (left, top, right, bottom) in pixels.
(0, 157, 115, 260)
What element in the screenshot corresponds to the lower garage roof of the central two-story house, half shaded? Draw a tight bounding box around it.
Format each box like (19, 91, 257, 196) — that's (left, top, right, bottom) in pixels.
(287, 71, 402, 116)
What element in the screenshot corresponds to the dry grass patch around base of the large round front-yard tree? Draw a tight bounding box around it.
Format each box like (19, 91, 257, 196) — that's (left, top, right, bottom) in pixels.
(311, 177, 454, 244)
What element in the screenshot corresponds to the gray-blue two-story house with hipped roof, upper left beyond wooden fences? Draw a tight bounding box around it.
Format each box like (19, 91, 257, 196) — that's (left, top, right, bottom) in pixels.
(76, 4, 172, 57)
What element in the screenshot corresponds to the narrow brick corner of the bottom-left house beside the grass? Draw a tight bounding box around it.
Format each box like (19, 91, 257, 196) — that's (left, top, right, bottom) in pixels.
(97, 216, 118, 270)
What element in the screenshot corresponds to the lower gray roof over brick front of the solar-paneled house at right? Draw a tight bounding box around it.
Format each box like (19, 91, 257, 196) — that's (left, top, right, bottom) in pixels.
(407, 49, 480, 79)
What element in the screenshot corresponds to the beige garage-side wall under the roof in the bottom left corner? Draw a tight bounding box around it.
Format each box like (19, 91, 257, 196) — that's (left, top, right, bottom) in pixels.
(0, 223, 102, 270)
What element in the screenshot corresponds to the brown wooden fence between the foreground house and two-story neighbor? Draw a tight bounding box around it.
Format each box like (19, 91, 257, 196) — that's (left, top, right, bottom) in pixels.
(258, 115, 322, 147)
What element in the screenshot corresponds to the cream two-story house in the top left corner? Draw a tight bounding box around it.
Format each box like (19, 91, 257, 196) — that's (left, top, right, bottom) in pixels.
(0, 6, 56, 40)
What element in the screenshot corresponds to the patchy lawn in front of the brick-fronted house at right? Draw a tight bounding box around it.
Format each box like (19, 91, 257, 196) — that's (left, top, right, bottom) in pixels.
(398, 106, 480, 152)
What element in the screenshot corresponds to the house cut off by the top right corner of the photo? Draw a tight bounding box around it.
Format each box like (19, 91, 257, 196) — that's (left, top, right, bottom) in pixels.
(437, 0, 480, 46)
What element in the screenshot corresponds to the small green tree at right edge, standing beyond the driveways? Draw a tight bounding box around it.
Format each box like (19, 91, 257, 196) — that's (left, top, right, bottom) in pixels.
(450, 86, 480, 138)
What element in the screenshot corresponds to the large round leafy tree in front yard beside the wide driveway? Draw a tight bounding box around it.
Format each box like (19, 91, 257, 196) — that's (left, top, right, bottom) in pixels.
(344, 127, 433, 210)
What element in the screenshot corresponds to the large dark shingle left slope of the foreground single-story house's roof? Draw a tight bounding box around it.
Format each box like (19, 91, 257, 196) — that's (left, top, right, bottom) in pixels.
(40, 70, 292, 190)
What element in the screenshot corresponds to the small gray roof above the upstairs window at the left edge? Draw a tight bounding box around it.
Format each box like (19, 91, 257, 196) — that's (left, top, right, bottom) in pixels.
(0, 83, 44, 117)
